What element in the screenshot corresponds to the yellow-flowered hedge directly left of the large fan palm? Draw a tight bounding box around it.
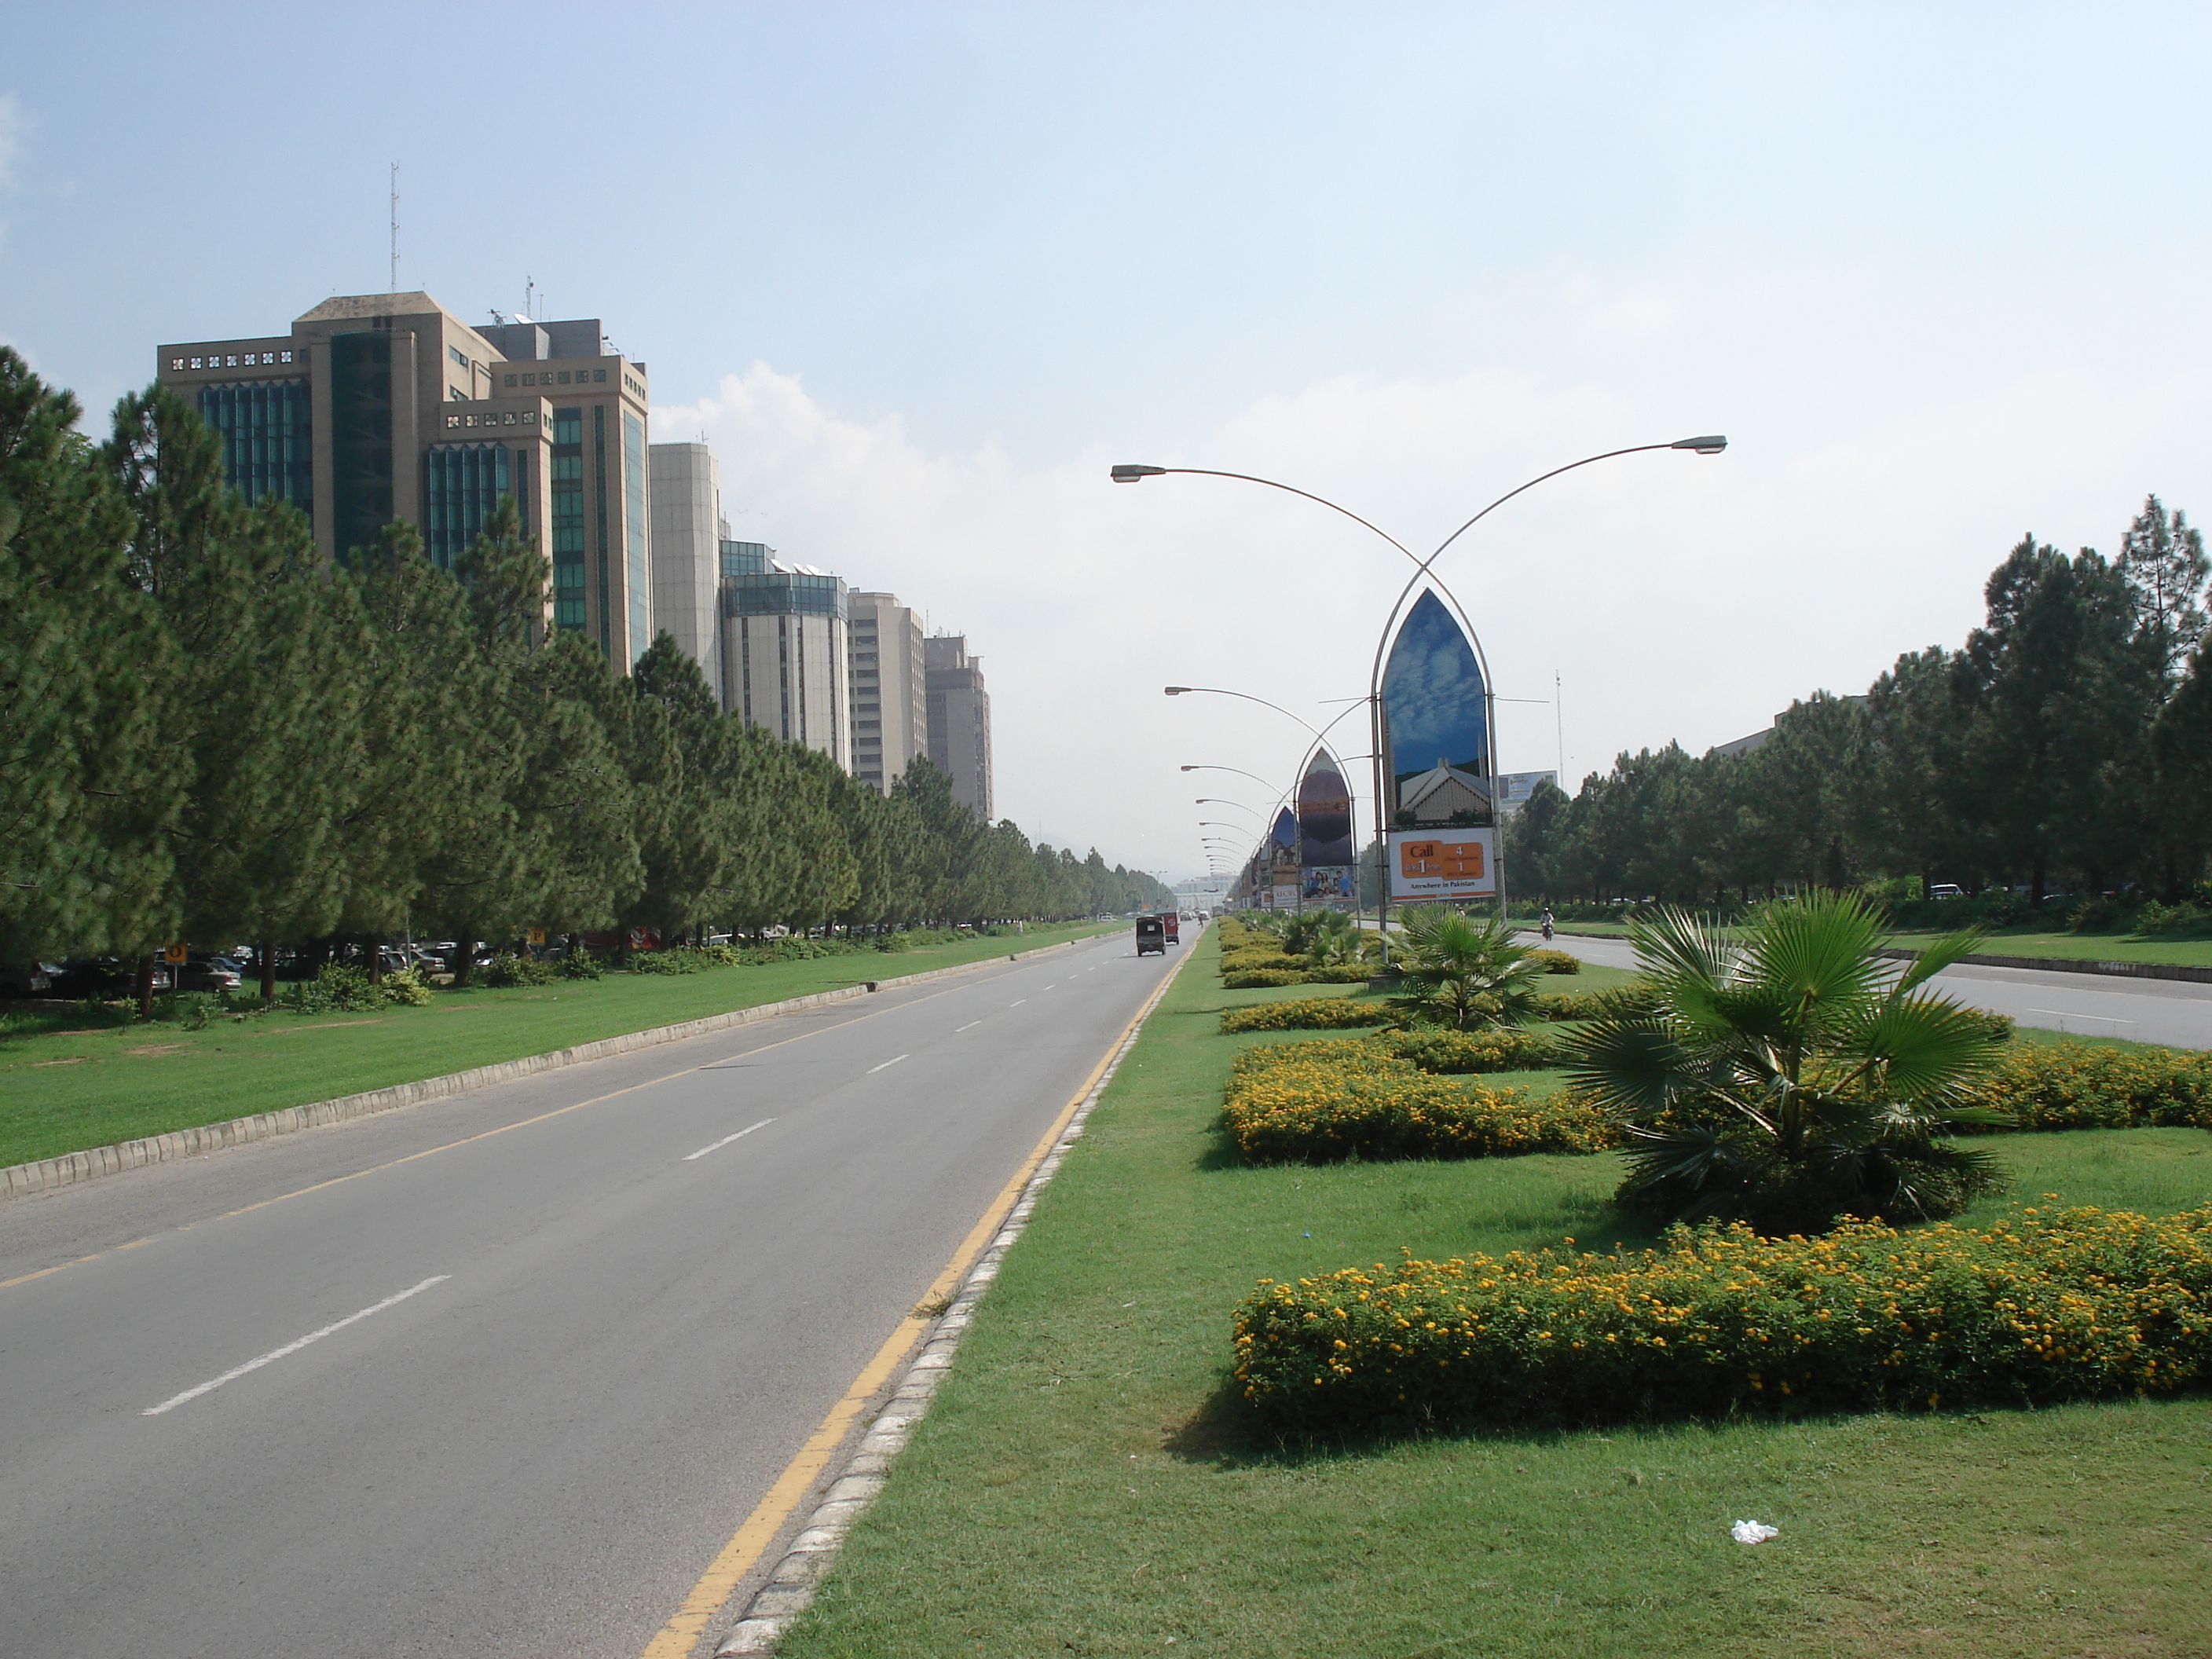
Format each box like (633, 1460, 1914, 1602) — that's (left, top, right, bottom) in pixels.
(1223, 1038, 1615, 1163)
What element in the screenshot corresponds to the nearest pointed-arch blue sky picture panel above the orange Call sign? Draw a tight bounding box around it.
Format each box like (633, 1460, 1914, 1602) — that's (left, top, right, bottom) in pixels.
(1382, 593, 1496, 825)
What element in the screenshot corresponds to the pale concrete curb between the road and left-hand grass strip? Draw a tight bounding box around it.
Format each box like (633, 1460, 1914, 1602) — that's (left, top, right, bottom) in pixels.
(0, 933, 1104, 1201)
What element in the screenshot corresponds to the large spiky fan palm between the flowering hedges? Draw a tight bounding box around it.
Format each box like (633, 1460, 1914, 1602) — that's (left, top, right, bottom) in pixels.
(1569, 894, 2009, 1230)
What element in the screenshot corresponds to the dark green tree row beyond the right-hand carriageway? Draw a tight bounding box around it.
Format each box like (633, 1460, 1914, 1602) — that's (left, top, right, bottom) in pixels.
(1507, 496, 2212, 907)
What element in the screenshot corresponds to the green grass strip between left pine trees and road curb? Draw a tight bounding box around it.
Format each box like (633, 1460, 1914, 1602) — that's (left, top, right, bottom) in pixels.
(0, 922, 1108, 1168)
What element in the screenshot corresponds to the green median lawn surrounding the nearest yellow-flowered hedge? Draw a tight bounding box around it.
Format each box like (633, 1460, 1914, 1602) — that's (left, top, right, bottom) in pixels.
(783, 940, 2212, 1659)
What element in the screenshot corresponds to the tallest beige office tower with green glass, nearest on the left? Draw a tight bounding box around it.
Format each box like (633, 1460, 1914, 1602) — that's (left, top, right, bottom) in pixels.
(157, 295, 653, 672)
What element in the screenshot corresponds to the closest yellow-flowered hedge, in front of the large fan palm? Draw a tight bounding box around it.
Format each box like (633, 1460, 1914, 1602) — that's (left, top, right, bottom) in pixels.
(1236, 1208, 2212, 1431)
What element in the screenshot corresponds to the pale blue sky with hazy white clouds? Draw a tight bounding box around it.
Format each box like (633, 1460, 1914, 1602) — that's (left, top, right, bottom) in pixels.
(0, 0, 2212, 878)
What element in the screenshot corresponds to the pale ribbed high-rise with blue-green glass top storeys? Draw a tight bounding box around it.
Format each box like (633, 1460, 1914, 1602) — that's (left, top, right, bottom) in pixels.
(721, 542, 851, 772)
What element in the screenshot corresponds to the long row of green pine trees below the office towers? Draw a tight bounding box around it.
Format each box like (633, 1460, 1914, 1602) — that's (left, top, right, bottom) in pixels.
(0, 347, 1166, 995)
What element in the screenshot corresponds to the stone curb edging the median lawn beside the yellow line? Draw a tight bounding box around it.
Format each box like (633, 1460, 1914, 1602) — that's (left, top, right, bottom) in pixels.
(715, 940, 1196, 1659)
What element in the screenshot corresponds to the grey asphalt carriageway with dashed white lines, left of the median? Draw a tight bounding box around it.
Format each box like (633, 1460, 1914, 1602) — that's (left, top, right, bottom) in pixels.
(0, 933, 1188, 1659)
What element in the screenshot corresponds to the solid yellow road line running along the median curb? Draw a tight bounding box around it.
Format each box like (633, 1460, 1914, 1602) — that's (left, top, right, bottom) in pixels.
(639, 956, 1190, 1659)
